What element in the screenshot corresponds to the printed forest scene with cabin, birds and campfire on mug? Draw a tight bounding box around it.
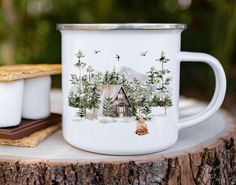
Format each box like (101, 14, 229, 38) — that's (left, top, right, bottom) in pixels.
(68, 49, 172, 135)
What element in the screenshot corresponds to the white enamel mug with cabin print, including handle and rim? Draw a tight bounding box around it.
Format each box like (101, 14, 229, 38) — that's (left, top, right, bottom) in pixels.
(57, 24, 226, 155)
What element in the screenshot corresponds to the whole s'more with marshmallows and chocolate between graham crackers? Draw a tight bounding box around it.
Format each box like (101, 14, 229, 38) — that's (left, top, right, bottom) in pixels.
(0, 64, 61, 147)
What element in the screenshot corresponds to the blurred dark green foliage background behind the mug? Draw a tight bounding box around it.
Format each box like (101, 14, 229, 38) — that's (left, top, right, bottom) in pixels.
(0, 0, 236, 113)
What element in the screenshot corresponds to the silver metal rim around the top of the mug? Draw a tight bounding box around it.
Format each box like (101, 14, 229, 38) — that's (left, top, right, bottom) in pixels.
(57, 23, 187, 30)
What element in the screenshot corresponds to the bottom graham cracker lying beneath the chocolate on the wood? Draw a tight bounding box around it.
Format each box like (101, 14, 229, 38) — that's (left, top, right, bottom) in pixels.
(0, 123, 61, 147)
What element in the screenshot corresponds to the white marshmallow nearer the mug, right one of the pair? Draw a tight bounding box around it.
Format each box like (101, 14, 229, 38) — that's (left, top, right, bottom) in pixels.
(22, 76, 51, 119)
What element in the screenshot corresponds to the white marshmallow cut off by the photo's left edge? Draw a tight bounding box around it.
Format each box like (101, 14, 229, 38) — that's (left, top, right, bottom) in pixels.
(0, 80, 24, 128)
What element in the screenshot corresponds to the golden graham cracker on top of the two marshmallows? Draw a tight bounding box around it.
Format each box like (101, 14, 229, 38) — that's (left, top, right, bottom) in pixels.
(0, 64, 61, 82)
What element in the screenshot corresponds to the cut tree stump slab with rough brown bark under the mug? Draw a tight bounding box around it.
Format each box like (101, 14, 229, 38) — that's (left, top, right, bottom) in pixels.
(0, 94, 236, 185)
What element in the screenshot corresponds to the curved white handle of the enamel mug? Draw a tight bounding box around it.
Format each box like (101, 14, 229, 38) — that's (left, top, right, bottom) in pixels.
(178, 52, 226, 129)
